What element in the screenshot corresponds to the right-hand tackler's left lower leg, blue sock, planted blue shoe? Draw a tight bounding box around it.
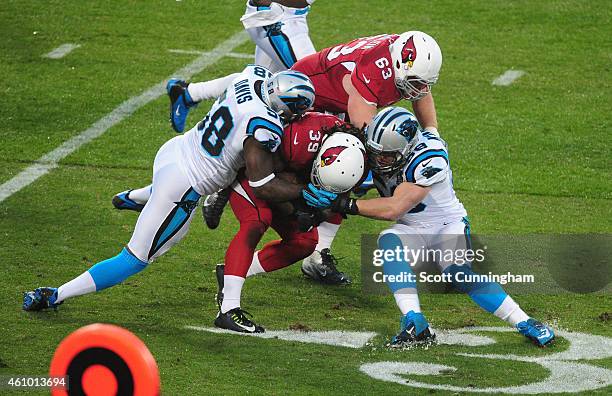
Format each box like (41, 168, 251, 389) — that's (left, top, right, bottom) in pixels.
(378, 229, 436, 348)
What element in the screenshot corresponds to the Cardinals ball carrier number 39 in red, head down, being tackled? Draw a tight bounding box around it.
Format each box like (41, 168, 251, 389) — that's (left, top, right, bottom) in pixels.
(215, 119, 366, 332)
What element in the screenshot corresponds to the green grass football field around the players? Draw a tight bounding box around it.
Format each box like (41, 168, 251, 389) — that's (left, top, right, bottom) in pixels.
(0, 0, 612, 395)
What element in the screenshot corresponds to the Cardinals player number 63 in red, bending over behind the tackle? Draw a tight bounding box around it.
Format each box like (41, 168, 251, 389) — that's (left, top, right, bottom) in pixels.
(203, 31, 442, 283)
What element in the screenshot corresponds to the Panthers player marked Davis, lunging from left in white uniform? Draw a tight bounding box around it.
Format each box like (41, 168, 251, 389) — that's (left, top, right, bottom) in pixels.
(23, 65, 335, 324)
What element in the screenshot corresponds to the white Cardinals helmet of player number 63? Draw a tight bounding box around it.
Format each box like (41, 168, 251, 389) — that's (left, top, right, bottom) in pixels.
(389, 30, 442, 101)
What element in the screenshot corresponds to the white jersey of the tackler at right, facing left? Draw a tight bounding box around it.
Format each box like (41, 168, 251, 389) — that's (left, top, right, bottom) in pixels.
(373, 131, 467, 226)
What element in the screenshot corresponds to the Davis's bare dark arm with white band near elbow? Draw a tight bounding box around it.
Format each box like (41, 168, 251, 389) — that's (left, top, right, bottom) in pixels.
(244, 138, 304, 202)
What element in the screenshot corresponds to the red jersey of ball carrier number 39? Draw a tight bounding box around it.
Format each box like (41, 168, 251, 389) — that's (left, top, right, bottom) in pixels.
(280, 112, 343, 174)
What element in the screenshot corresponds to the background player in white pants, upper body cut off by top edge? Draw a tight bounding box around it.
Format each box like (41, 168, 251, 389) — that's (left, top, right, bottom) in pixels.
(167, 0, 315, 133)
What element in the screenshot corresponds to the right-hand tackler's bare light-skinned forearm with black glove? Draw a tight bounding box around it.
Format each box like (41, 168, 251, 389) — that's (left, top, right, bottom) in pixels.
(332, 182, 431, 221)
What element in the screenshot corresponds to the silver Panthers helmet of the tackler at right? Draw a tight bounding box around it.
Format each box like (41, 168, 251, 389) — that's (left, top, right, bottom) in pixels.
(366, 107, 420, 173)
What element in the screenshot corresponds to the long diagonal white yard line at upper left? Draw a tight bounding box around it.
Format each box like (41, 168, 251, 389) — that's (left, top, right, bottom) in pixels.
(0, 31, 249, 202)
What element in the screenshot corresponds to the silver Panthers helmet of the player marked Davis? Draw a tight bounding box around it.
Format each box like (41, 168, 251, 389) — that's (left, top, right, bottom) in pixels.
(266, 70, 315, 122)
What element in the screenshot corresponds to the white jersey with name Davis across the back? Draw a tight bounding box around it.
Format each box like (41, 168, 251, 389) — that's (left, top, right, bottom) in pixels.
(178, 65, 283, 195)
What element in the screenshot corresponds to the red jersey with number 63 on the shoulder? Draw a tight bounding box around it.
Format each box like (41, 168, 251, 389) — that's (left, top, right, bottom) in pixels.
(292, 34, 402, 113)
